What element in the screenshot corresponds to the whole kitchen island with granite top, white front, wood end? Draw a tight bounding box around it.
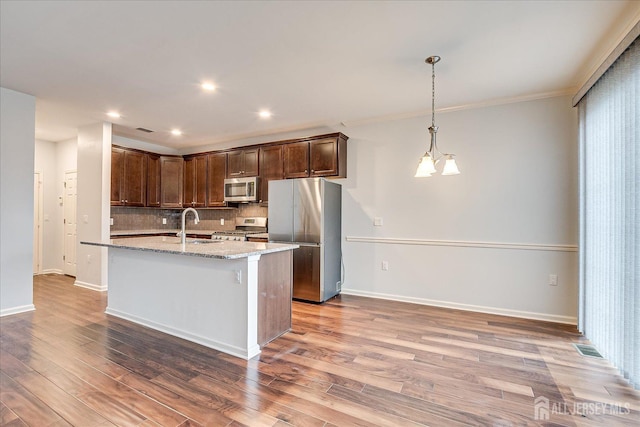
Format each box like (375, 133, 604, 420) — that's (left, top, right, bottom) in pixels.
(80, 236, 297, 359)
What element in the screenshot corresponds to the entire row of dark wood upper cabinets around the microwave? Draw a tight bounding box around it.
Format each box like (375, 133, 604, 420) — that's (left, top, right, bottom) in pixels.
(111, 133, 348, 208)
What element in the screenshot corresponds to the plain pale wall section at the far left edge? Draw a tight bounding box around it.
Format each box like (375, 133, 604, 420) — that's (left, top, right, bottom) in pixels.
(0, 88, 35, 316)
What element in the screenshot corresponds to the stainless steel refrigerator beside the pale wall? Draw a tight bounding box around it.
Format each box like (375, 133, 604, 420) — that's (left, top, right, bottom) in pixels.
(268, 178, 342, 302)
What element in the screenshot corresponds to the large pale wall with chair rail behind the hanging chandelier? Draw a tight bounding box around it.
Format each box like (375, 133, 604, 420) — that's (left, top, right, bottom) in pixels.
(341, 97, 578, 323)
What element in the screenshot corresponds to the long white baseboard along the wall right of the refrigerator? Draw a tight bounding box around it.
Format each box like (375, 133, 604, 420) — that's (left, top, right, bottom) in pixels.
(341, 288, 578, 325)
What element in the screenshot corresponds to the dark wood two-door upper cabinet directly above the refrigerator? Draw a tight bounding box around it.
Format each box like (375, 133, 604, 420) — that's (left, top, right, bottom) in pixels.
(284, 133, 347, 178)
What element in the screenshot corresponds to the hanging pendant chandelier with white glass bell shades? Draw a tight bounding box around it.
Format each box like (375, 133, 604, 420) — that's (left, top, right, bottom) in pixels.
(415, 56, 460, 178)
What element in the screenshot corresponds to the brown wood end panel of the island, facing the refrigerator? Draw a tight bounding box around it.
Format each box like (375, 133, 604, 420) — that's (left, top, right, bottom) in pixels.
(258, 251, 293, 347)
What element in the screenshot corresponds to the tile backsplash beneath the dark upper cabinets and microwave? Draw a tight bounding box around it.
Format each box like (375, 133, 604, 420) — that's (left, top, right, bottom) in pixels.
(111, 203, 268, 231)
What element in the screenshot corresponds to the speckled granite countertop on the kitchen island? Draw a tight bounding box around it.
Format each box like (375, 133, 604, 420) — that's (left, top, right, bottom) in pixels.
(80, 236, 298, 259)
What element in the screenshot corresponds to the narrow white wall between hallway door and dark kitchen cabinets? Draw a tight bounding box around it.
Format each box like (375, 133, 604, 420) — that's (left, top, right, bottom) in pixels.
(75, 122, 111, 290)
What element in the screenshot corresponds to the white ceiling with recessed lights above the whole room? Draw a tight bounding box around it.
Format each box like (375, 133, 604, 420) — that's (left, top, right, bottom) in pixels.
(0, 0, 640, 149)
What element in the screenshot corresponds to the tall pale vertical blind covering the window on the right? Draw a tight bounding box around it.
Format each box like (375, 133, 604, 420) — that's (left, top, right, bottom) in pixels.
(578, 39, 640, 389)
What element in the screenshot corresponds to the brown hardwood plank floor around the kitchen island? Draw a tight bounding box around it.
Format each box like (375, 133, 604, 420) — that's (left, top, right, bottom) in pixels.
(0, 275, 640, 427)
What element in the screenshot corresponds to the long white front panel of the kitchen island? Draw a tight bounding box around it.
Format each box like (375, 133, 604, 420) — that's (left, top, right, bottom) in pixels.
(106, 248, 260, 359)
